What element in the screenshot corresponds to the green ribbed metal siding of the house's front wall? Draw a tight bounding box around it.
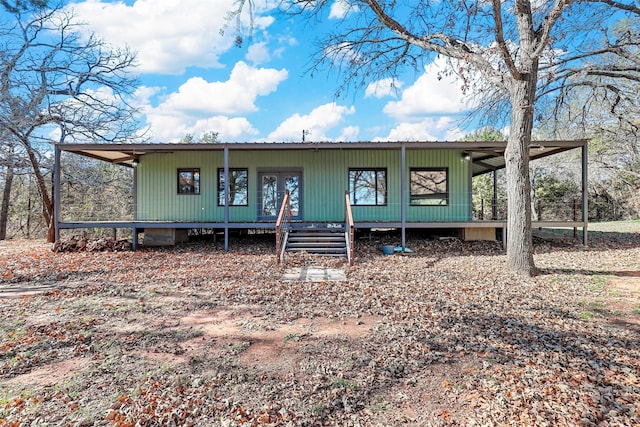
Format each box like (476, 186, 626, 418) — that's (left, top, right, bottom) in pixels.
(137, 148, 470, 222)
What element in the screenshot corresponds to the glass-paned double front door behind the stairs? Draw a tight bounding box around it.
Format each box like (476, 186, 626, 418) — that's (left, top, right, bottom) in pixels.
(258, 171, 302, 221)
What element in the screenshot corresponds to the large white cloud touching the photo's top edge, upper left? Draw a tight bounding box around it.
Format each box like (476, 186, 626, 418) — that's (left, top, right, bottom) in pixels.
(70, 0, 273, 74)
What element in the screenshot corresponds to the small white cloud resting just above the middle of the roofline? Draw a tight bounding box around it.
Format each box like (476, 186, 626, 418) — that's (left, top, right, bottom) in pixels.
(267, 102, 355, 142)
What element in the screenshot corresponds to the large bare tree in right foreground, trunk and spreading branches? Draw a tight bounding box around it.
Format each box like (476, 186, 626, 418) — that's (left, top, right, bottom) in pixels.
(230, 0, 640, 275)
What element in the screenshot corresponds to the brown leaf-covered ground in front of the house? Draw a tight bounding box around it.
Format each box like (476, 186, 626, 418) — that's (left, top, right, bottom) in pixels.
(0, 229, 640, 426)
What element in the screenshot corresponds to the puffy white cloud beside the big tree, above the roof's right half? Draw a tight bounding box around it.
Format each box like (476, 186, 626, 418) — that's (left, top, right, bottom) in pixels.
(384, 59, 470, 120)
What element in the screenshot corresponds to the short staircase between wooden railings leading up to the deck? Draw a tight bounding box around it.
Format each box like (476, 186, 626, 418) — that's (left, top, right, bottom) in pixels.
(284, 223, 348, 258)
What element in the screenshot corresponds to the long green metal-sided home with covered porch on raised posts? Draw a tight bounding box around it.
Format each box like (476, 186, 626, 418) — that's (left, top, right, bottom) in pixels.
(54, 140, 587, 264)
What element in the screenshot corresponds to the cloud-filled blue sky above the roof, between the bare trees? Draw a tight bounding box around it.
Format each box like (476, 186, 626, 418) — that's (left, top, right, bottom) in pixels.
(69, 0, 476, 142)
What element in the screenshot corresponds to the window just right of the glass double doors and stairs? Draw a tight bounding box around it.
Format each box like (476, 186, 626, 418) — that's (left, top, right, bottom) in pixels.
(349, 169, 387, 206)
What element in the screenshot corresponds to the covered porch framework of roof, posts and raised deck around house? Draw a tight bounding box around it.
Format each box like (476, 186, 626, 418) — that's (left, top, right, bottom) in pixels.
(54, 140, 588, 254)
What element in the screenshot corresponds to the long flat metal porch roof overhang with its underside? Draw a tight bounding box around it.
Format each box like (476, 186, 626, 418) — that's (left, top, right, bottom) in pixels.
(56, 140, 587, 176)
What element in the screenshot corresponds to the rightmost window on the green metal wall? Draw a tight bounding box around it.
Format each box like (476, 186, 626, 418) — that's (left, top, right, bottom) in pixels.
(410, 168, 449, 206)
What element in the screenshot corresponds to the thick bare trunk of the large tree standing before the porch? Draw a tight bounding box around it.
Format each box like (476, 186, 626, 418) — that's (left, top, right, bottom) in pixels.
(504, 77, 536, 276)
